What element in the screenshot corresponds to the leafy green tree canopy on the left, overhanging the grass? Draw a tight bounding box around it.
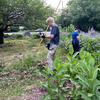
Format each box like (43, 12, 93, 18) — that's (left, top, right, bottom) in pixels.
(0, 0, 53, 29)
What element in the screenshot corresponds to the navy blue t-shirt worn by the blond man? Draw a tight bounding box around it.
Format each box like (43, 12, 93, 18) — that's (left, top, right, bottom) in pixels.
(50, 24, 60, 45)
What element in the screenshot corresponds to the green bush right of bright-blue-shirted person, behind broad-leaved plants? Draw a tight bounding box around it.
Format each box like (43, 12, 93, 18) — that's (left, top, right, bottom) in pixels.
(80, 35, 100, 65)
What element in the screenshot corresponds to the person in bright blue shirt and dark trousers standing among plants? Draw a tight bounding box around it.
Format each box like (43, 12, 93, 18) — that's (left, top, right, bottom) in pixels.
(72, 29, 80, 53)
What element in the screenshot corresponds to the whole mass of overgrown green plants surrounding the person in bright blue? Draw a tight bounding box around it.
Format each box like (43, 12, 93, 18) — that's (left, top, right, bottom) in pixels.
(41, 25, 100, 100)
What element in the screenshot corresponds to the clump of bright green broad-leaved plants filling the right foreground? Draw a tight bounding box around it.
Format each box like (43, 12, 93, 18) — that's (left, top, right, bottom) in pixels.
(41, 45, 100, 100)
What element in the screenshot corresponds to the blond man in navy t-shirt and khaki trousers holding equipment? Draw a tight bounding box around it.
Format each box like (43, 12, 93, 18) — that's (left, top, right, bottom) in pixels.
(42, 17, 60, 72)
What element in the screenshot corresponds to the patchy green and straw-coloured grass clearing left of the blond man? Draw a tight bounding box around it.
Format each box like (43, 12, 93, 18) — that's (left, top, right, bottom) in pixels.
(0, 38, 66, 100)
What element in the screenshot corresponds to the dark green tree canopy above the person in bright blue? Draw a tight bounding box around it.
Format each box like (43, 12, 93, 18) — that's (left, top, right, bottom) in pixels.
(58, 0, 100, 31)
